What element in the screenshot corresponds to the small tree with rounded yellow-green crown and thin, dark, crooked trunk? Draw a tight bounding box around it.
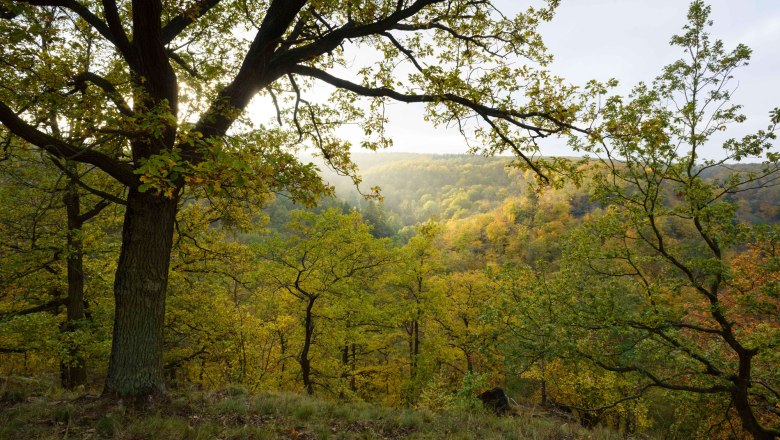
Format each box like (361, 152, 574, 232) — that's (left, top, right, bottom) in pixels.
(260, 209, 391, 394)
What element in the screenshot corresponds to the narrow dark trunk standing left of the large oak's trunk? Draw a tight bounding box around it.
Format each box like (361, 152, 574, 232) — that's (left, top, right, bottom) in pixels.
(60, 175, 87, 390)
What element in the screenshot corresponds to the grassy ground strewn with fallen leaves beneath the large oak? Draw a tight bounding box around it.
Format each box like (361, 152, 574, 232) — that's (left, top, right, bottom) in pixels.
(0, 380, 632, 440)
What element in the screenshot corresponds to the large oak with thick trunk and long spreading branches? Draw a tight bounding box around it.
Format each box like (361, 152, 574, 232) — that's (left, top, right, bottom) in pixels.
(0, 0, 576, 396)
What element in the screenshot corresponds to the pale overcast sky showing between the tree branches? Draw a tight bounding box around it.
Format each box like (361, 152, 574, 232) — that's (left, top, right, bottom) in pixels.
(340, 0, 780, 155)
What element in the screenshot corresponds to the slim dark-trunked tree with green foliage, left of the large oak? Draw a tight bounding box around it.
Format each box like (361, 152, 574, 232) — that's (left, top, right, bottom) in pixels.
(0, 144, 119, 389)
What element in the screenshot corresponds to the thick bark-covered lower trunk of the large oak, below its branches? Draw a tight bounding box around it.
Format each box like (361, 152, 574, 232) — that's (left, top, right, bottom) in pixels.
(103, 189, 177, 397)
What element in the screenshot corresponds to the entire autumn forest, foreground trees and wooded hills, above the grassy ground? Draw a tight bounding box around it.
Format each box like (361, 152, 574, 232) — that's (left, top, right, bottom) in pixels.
(0, 0, 780, 439)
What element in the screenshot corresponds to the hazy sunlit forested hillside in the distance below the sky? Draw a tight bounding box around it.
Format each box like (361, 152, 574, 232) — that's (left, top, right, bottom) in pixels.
(320, 153, 780, 234)
